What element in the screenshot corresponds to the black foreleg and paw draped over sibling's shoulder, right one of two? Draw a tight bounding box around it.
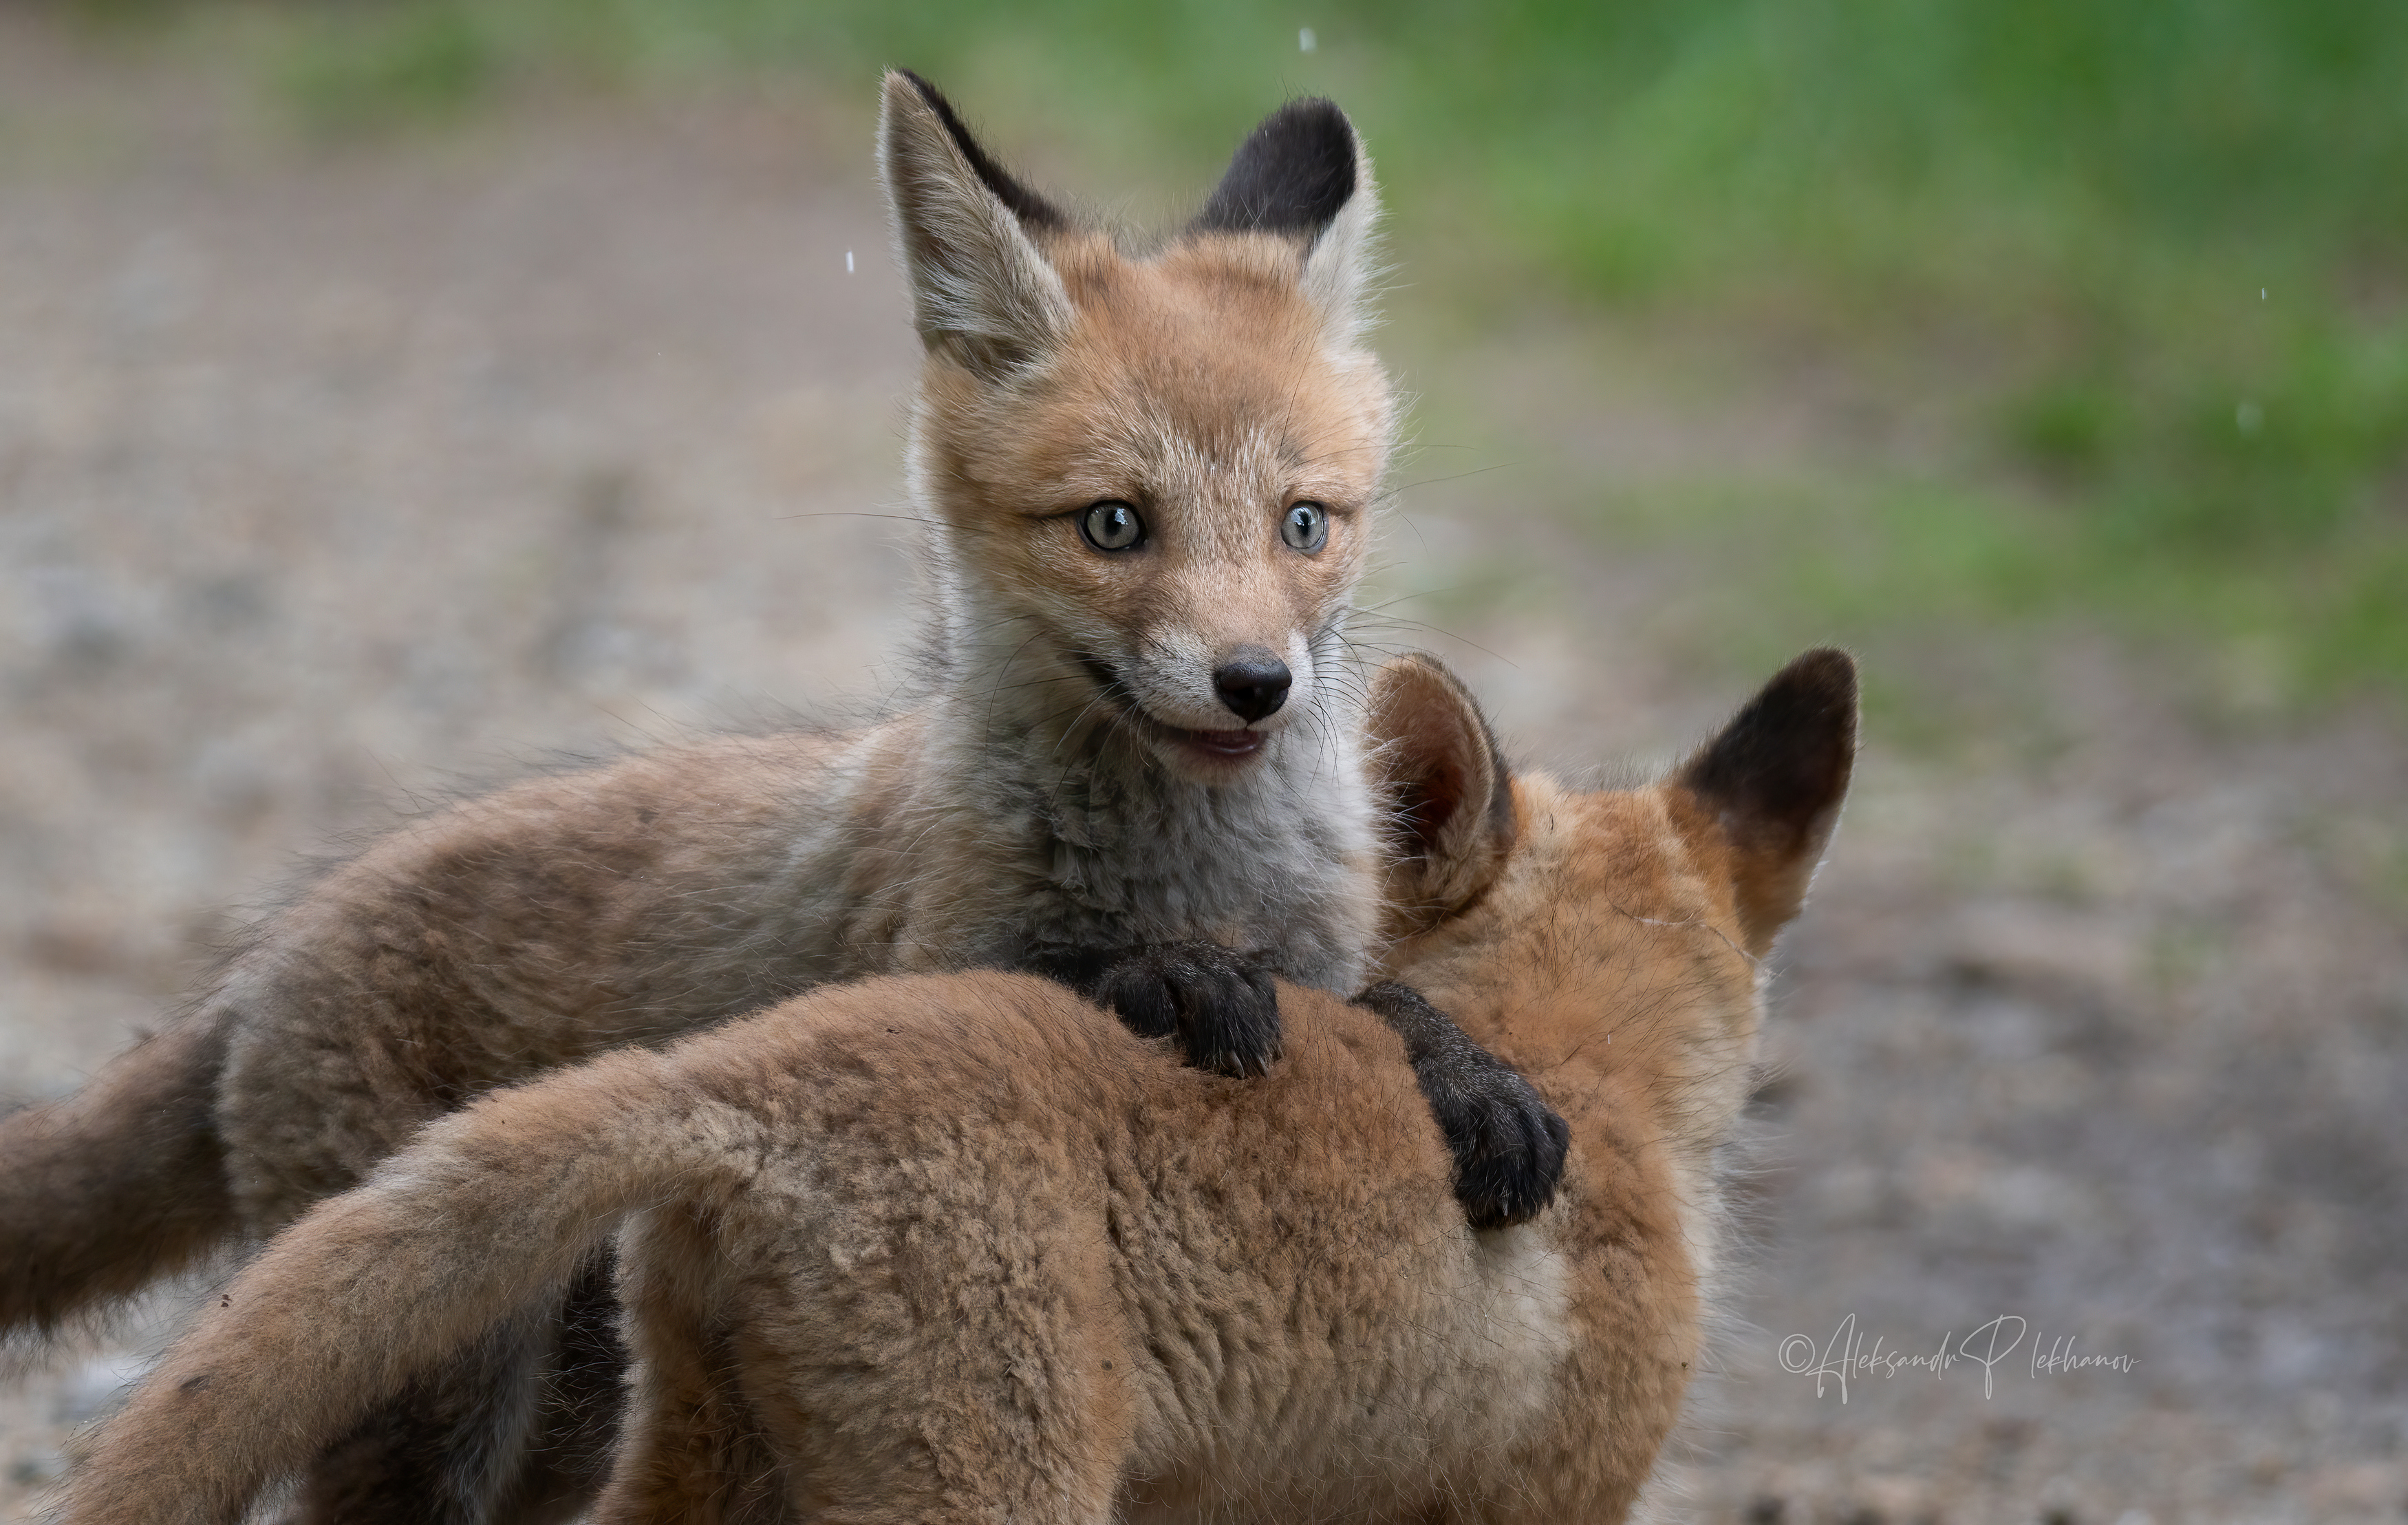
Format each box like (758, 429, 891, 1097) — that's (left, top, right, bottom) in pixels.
(1356, 983, 1573, 1228)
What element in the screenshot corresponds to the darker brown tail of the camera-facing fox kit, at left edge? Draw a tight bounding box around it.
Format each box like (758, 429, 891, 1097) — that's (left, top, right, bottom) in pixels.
(0, 1019, 236, 1339)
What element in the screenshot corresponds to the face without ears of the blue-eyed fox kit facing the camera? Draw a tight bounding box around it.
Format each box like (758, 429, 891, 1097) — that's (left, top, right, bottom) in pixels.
(925, 234, 1390, 778)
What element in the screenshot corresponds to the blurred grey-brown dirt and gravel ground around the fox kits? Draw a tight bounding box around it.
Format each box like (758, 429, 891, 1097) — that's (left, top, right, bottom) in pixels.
(0, 12, 2408, 1525)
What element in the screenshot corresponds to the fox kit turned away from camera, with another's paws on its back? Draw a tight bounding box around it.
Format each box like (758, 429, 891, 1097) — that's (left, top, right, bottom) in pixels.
(65, 650, 1857, 1525)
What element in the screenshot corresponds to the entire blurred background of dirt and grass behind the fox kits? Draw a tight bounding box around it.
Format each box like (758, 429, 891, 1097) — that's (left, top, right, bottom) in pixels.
(0, 0, 2408, 1525)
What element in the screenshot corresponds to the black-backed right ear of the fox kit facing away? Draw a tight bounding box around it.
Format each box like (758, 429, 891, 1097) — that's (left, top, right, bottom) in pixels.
(1671, 646, 1857, 957)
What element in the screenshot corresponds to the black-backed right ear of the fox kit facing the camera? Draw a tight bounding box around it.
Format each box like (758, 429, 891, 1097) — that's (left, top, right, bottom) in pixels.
(1192, 96, 1380, 340)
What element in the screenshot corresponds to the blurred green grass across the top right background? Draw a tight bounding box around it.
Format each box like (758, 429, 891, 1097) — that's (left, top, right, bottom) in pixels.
(94, 0, 2408, 703)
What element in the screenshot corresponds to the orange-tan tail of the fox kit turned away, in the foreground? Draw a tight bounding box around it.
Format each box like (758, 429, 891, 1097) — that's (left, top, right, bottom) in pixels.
(61, 1055, 742, 1525)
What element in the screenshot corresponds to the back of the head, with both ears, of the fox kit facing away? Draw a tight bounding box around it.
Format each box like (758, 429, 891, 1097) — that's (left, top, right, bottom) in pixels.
(1368, 648, 1857, 1069)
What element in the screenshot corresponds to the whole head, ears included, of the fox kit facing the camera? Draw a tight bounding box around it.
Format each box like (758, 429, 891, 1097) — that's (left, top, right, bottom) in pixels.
(879, 72, 1395, 783)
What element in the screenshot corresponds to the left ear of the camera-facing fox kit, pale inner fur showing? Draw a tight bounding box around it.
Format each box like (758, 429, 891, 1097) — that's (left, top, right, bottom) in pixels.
(879, 70, 1072, 378)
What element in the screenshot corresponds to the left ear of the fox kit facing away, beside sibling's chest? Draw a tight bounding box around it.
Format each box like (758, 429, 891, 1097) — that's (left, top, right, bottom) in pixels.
(1366, 653, 1520, 935)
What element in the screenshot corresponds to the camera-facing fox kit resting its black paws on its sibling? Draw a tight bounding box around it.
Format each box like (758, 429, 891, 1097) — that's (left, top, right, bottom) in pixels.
(0, 75, 1560, 1517)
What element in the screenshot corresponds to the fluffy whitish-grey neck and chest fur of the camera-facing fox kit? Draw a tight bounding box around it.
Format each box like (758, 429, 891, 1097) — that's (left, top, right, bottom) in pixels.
(908, 552, 1377, 992)
